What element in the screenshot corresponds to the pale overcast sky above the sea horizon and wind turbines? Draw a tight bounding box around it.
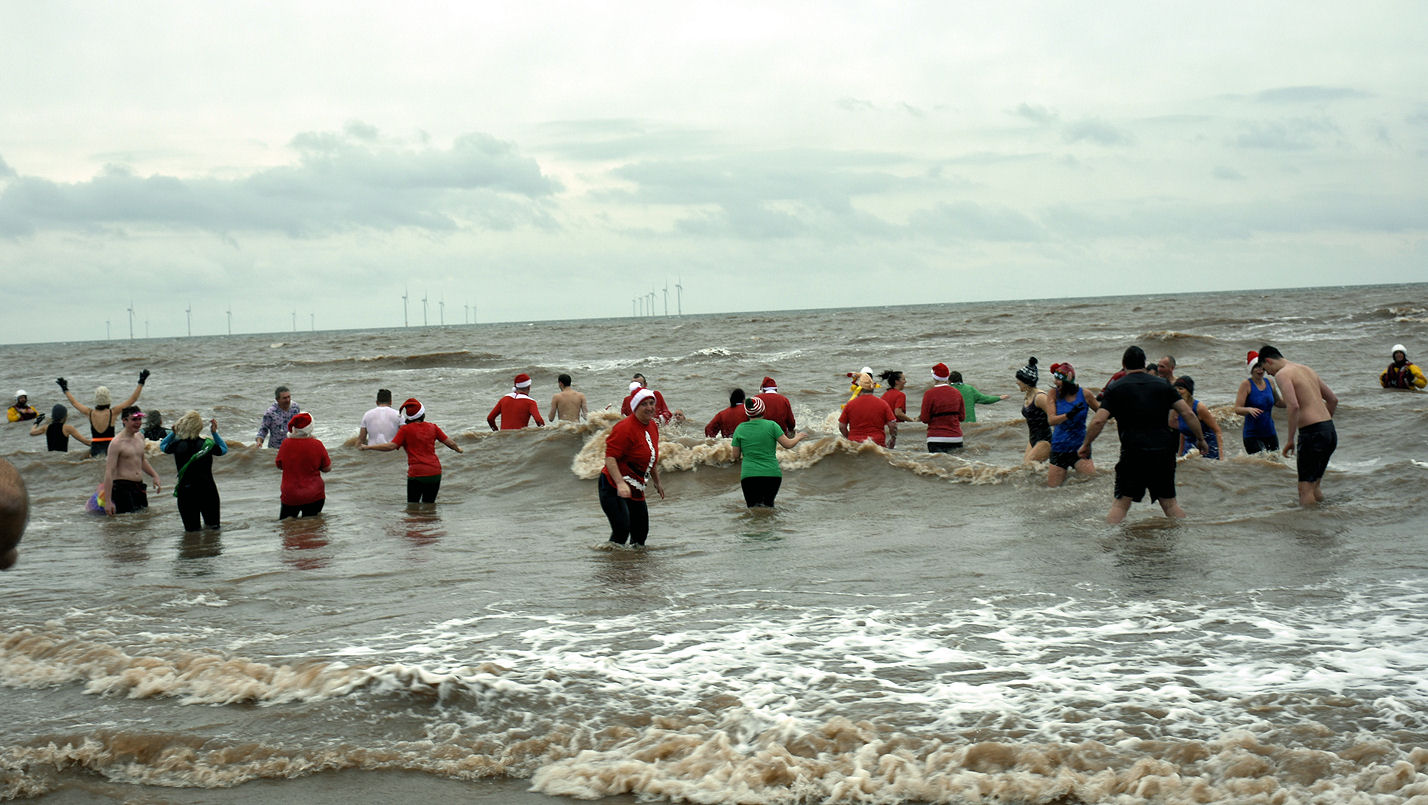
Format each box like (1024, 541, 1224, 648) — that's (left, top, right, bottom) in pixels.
(0, 0, 1428, 343)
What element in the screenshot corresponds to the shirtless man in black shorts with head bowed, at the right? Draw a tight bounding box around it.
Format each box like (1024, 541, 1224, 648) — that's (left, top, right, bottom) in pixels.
(1259, 344, 1338, 507)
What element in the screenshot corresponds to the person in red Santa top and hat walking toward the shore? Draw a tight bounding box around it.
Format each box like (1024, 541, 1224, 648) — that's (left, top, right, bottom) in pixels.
(598, 388, 664, 545)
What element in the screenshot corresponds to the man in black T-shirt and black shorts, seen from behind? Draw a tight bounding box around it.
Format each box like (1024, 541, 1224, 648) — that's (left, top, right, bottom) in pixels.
(1080, 345, 1210, 524)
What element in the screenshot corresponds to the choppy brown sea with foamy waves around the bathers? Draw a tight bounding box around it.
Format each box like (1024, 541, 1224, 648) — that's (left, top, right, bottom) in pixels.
(0, 284, 1428, 805)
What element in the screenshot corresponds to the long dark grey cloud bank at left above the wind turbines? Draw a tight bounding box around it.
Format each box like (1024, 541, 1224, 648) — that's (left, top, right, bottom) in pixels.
(0, 123, 560, 237)
